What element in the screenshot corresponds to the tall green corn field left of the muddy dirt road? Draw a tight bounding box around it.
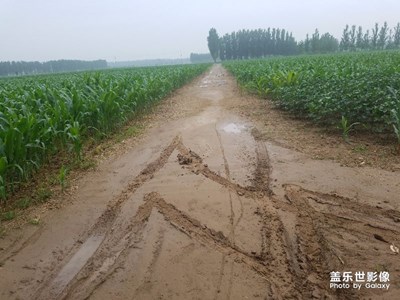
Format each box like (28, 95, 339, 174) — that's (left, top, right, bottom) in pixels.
(0, 65, 209, 199)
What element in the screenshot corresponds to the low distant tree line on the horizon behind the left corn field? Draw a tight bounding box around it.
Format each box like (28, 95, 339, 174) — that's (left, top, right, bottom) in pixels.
(0, 59, 107, 76)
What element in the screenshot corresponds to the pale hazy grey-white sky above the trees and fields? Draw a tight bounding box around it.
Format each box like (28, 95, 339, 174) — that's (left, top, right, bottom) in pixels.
(0, 0, 400, 61)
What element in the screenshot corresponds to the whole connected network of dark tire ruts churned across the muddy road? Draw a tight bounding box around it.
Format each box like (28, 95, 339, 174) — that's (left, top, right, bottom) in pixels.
(30, 131, 400, 299)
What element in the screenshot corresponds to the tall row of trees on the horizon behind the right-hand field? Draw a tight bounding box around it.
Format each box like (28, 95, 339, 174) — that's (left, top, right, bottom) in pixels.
(207, 22, 400, 61)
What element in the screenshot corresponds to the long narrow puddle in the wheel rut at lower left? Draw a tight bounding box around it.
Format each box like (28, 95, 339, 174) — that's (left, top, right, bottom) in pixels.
(52, 235, 104, 295)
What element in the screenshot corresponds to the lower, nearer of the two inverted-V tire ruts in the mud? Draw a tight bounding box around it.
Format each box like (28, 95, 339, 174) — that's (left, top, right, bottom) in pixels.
(65, 192, 276, 299)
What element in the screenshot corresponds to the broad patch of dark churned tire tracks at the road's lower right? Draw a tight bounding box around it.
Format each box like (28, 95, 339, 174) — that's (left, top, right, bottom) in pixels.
(275, 184, 400, 299)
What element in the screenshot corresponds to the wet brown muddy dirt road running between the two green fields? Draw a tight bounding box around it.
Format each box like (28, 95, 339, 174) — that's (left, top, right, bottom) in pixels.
(0, 66, 400, 299)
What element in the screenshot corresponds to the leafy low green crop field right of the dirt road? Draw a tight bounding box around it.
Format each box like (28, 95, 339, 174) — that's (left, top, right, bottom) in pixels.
(224, 51, 400, 132)
